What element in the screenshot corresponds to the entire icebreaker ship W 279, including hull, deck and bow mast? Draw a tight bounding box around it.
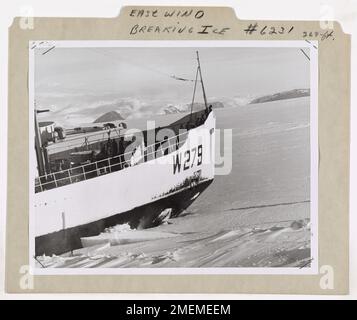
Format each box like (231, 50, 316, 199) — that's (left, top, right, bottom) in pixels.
(34, 53, 215, 256)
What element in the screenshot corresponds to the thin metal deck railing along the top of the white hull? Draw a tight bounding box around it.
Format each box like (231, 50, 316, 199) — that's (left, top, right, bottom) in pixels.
(35, 131, 188, 193)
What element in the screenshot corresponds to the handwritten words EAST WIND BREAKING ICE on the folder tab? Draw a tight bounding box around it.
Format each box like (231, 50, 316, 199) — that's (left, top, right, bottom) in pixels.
(129, 9, 230, 35)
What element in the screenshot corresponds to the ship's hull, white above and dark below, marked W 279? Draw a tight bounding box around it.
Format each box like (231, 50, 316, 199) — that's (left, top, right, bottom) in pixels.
(31, 112, 215, 256)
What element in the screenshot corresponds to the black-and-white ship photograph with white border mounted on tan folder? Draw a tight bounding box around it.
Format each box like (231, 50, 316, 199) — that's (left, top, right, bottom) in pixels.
(29, 41, 318, 274)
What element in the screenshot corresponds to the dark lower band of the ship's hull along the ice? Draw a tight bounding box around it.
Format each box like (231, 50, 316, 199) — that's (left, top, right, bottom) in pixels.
(35, 180, 213, 256)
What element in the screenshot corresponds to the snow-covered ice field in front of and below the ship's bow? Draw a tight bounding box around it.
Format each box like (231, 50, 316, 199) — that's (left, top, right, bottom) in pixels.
(37, 97, 311, 268)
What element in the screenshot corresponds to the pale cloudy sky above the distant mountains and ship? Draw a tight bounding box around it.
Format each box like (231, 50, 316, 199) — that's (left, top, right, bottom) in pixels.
(35, 48, 310, 101)
